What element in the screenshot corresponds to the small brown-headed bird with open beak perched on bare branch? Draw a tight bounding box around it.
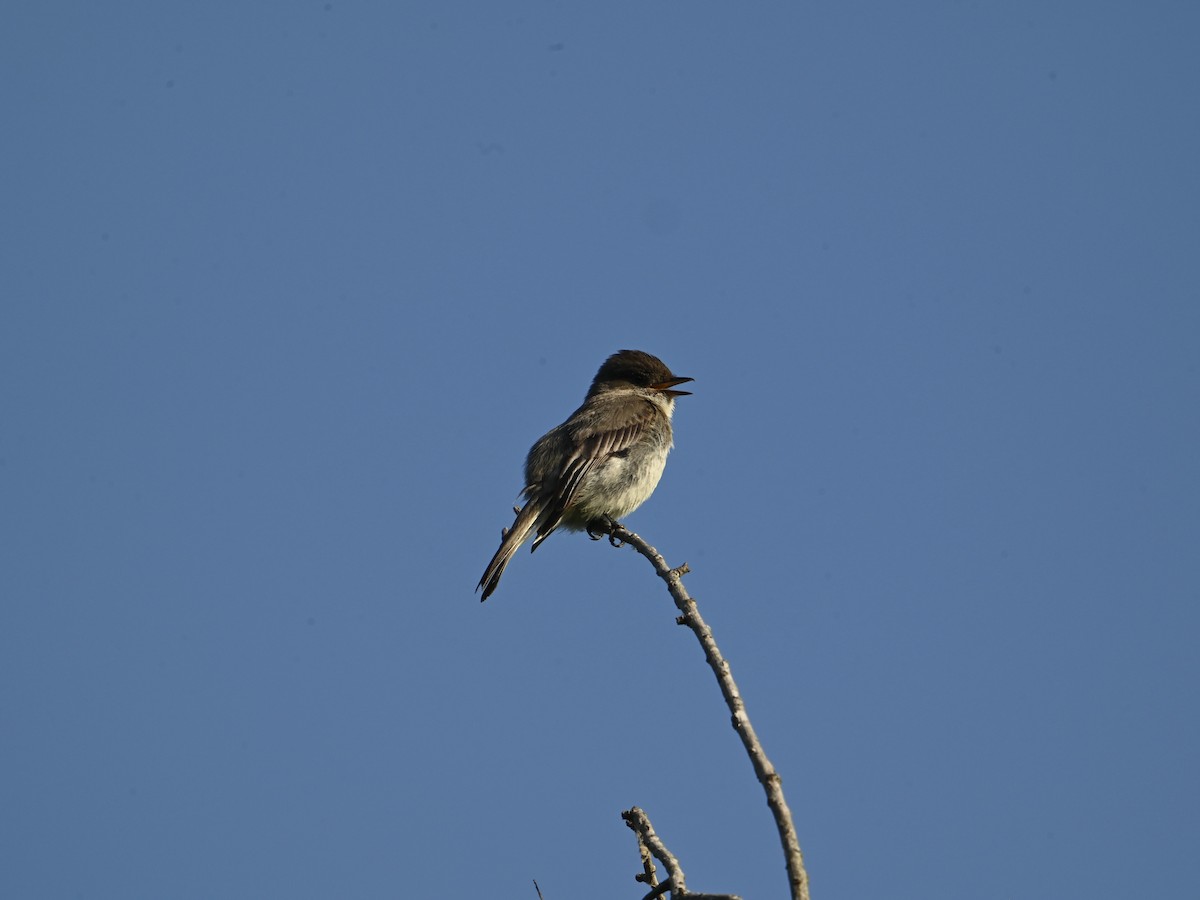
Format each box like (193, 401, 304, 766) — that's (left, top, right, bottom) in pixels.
(475, 350, 692, 600)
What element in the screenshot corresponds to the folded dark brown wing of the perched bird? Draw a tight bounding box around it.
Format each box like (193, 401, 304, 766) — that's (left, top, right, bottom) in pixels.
(532, 401, 660, 550)
